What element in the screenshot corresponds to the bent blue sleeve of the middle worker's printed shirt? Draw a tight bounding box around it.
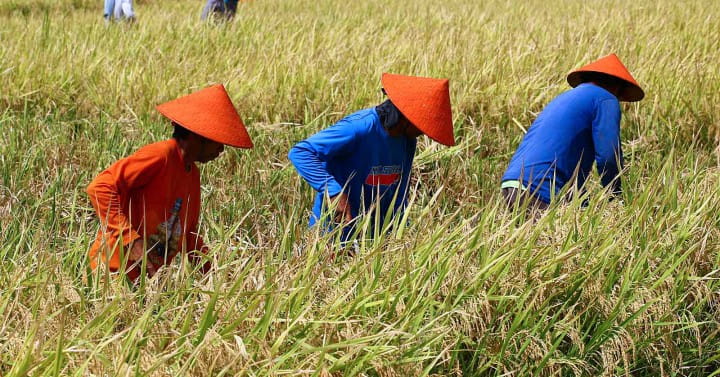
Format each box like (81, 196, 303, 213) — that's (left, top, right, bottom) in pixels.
(288, 121, 357, 196)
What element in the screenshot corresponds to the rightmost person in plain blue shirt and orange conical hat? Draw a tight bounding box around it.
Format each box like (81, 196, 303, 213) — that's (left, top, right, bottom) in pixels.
(501, 54, 645, 210)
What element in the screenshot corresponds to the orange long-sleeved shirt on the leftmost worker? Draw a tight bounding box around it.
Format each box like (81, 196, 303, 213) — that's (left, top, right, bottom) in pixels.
(87, 139, 209, 278)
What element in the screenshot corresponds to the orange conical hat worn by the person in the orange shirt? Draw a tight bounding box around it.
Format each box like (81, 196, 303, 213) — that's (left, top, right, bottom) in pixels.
(155, 84, 253, 148)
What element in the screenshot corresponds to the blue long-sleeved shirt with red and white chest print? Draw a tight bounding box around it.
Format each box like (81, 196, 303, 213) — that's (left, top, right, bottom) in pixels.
(288, 108, 416, 232)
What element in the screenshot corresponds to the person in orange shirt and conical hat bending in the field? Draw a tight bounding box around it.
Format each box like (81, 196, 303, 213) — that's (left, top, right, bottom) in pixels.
(87, 85, 253, 280)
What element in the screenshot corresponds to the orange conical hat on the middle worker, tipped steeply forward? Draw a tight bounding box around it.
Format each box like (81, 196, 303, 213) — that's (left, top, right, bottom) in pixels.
(381, 73, 455, 146)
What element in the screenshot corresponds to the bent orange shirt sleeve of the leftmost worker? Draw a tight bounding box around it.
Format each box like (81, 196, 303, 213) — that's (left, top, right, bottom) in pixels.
(86, 150, 165, 250)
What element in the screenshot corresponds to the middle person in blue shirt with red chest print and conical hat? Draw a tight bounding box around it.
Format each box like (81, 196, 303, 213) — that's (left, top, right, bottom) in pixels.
(288, 73, 455, 238)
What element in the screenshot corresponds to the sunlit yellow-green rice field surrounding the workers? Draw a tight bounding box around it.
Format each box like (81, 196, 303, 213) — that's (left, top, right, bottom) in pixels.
(0, 0, 720, 376)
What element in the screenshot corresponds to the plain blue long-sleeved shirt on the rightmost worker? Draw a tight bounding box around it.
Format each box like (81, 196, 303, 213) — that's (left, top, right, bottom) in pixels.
(502, 83, 623, 203)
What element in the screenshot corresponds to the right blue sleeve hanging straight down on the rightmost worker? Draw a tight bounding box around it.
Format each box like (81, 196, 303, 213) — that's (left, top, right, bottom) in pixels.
(592, 99, 623, 195)
